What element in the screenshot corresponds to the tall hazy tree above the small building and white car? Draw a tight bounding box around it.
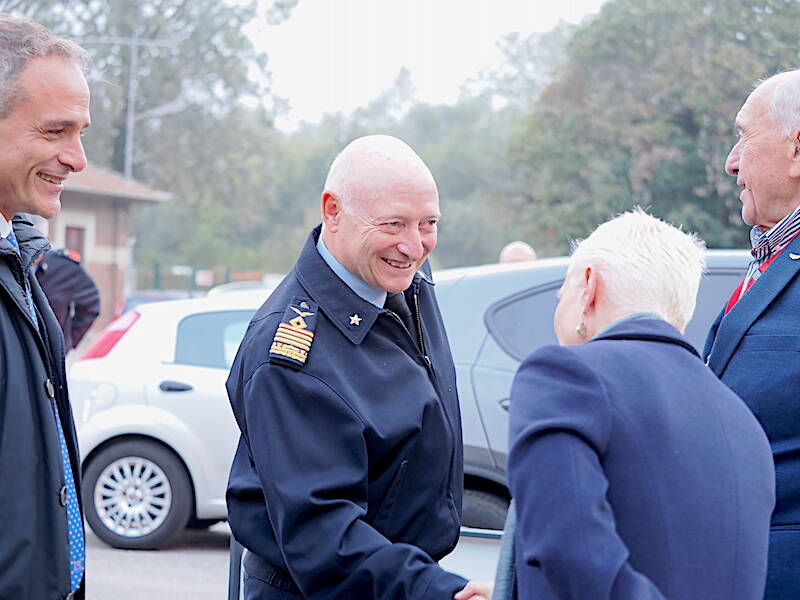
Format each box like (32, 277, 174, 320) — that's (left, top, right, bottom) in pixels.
(9, 0, 296, 268)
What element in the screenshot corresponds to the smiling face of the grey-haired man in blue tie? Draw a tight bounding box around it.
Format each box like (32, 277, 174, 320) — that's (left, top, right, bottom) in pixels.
(0, 56, 89, 220)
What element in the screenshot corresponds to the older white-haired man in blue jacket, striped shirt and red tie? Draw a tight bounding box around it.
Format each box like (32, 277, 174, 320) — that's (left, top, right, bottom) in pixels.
(703, 70, 800, 600)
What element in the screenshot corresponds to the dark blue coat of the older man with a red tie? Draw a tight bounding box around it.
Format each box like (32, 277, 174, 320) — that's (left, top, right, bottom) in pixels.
(703, 232, 800, 600)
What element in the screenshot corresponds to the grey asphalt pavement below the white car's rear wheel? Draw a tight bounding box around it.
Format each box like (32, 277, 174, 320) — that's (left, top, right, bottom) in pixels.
(86, 523, 230, 600)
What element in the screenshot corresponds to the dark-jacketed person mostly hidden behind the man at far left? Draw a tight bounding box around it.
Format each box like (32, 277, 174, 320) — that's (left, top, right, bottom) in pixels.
(36, 250, 100, 352)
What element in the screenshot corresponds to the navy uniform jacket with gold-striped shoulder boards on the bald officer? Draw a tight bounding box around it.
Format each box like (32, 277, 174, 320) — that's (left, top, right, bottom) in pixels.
(227, 227, 466, 600)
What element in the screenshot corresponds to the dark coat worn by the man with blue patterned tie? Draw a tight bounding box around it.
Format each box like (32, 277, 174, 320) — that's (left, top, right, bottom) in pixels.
(0, 216, 84, 600)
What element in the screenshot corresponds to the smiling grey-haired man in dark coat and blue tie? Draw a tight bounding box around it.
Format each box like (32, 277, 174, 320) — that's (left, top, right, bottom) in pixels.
(0, 15, 89, 600)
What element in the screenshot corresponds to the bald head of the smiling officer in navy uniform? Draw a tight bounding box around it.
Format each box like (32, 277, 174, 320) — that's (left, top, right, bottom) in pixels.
(321, 135, 439, 292)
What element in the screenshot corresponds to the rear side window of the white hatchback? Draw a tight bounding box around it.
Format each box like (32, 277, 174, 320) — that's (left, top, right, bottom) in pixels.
(175, 310, 255, 369)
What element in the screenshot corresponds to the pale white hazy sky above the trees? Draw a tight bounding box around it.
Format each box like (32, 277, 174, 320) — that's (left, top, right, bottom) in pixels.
(248, 0, 603, 129)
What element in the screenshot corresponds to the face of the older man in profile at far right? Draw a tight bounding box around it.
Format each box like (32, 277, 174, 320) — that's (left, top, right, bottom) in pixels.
(725, 81, 800, 230)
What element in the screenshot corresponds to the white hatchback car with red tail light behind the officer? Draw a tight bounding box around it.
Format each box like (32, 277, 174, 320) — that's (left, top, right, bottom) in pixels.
(69, 289, 262, 549)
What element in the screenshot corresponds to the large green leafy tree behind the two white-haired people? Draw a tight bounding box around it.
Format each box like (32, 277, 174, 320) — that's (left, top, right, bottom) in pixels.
(512, 0, 800, 251)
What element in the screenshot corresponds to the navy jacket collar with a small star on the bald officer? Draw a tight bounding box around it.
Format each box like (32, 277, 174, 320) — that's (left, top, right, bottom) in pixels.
(295, 225, 433, 344)
